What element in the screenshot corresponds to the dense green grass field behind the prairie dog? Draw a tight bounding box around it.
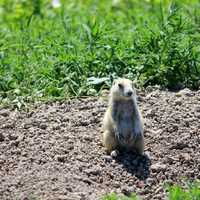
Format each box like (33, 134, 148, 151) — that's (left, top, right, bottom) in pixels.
(0, 0, 200, 106)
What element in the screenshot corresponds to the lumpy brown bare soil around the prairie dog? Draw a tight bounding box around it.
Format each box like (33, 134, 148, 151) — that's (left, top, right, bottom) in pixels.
(0, 89, 200, 200)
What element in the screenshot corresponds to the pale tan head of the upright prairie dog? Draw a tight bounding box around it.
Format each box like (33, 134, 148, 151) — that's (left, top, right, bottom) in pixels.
(110, 78, 135, 100)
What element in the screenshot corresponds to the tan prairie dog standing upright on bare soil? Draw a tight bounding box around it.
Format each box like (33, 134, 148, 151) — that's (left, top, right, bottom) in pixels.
(103, 78, 144, 155)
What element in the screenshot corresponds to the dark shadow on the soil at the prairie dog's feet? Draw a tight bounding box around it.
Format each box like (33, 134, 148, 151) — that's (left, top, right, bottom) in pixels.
(116, 152, 151, 180)
